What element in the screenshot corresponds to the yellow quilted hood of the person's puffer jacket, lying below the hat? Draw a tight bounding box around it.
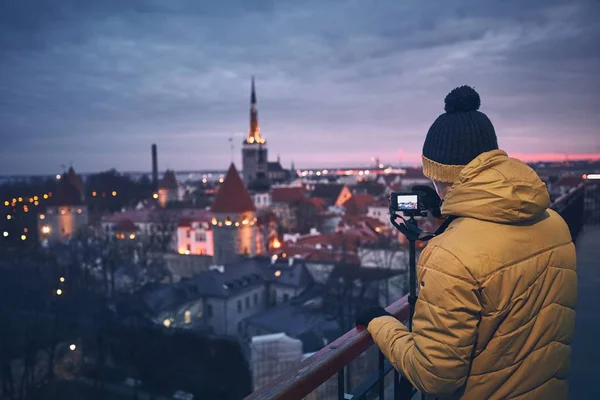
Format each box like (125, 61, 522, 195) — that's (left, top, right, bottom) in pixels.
(442, 150, 550, 224)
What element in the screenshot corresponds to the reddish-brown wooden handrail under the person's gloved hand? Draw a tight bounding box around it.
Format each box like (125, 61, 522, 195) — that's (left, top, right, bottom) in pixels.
(246, 296, 409, 400)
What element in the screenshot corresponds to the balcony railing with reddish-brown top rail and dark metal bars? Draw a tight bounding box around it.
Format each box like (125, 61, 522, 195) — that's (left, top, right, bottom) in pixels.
(246, 184, 600, 400)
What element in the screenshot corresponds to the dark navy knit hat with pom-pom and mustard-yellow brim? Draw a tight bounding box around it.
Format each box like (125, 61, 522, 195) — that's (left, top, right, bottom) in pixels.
(422, 86, 498, 183)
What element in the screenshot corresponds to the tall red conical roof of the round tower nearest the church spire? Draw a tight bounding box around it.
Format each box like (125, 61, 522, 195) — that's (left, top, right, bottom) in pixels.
(212, 163, 256, 213)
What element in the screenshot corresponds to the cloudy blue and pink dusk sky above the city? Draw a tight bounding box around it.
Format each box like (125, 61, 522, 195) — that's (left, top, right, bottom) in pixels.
(0, 0, 600, 174)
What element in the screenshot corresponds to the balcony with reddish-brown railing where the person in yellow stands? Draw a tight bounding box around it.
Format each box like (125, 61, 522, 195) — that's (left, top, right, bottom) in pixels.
(246, 184, 600, 400)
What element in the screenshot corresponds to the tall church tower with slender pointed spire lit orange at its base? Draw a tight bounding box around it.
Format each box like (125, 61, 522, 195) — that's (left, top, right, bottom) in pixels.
(242, 76, 269, 191)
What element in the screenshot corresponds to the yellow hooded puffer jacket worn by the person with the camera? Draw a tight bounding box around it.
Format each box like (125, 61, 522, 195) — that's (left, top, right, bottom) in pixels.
(368, 150, 577, 400)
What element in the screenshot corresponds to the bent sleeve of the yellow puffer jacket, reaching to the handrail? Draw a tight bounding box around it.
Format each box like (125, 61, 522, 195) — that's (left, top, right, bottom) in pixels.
(368, 246, 481, 396)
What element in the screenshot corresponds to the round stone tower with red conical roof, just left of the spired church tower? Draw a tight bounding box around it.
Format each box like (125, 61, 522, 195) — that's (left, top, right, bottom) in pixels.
(211, 163, 257, 265)
